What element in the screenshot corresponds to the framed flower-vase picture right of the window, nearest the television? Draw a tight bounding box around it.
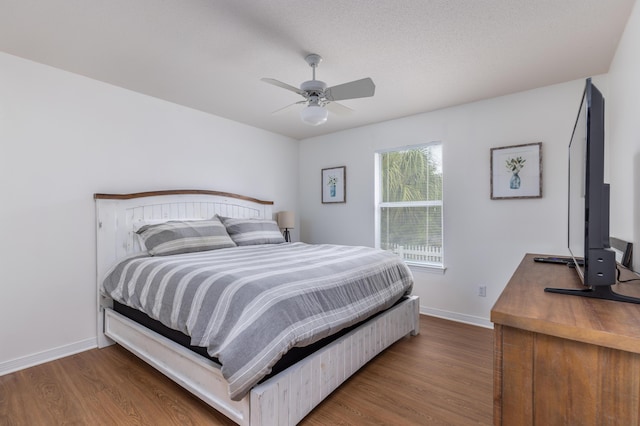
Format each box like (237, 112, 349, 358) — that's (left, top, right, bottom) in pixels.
(491, 142, 542, 200)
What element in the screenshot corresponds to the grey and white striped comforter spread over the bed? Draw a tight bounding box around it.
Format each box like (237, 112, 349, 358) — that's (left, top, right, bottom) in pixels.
(103, 243, 413, 400)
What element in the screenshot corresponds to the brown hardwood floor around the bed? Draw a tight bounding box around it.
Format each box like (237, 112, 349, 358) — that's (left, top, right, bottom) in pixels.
(0, 315, 493, 426)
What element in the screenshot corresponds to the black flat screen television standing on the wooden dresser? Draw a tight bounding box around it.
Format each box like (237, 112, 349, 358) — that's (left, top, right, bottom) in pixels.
(545, 78, 640, 303)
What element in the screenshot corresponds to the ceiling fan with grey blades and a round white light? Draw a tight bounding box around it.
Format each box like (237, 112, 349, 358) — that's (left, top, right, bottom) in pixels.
(261, 53, 376, 126)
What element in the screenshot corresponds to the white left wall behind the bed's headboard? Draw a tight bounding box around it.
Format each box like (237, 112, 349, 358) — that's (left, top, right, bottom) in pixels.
(0, 53, 298, 374)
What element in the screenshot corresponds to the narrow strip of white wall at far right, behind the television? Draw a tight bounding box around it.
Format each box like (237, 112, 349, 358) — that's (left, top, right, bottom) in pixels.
(606, 2, 640, 271)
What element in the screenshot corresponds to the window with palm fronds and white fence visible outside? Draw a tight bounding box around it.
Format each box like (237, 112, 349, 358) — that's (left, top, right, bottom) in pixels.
(376, 142, 443, 268)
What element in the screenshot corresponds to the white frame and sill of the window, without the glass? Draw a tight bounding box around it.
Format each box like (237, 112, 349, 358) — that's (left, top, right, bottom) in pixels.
(374, 141, 446, 274)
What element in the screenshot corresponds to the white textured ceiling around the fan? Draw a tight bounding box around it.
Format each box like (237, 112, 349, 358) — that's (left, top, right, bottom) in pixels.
(0, 0, 634, 139)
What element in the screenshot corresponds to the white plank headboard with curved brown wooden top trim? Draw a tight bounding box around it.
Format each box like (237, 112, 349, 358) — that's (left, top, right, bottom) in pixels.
(93, 190, 273, 346)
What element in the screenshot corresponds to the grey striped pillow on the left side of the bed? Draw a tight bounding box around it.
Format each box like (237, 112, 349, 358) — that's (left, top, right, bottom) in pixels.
(137, 217, 236, 256)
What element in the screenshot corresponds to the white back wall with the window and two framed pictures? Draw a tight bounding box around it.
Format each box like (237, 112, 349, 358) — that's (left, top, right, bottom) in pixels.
(299, 76, 606, 325)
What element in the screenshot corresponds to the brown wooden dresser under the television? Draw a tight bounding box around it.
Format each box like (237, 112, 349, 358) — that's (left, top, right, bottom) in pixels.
(491, 254, 640, 426)
